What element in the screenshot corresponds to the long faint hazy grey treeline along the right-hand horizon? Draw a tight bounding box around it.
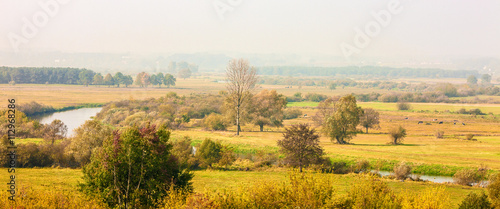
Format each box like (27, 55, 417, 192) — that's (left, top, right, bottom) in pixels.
(259, 66, 478, 78)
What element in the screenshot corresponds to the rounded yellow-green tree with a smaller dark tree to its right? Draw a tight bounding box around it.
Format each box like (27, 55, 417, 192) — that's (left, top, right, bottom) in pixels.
(323, 94, 362, 144)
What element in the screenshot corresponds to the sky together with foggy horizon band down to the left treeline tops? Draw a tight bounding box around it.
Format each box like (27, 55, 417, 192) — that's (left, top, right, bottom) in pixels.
(0, 0, 500, 73)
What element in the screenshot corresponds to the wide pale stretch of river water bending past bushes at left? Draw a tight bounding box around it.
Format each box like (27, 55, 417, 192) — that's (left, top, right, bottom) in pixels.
(33, 107, 102, 137)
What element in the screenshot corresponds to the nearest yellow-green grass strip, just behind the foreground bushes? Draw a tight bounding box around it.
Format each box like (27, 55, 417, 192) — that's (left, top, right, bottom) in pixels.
(0, 168, 483, 205)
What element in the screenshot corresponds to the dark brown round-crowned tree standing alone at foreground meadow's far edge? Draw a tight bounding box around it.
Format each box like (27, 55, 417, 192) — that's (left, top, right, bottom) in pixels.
(278, 124, 323, 172)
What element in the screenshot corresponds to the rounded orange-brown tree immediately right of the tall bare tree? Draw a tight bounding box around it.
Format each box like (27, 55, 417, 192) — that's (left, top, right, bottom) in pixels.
(251, 90, 287, 131)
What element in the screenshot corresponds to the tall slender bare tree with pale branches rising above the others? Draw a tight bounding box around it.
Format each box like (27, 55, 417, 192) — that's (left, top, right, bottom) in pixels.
(226, 59, 257, 135)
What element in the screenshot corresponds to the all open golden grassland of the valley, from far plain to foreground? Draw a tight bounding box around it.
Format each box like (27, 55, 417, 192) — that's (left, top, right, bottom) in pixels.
(0, 78, 500, 205)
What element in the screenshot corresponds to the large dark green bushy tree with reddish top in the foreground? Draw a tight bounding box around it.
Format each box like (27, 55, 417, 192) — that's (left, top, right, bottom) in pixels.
(80, 125, 193, 208)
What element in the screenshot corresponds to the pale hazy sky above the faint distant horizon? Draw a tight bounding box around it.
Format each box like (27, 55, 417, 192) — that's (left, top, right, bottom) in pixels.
(0, 0, 500, 58)
